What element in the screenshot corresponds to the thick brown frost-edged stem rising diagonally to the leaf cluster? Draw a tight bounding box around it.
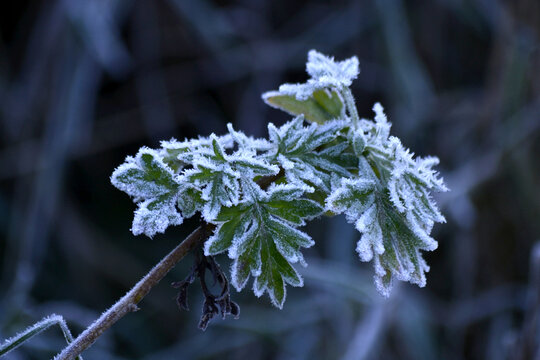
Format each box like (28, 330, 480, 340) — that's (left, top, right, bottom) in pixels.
(55, 224, 213, 360)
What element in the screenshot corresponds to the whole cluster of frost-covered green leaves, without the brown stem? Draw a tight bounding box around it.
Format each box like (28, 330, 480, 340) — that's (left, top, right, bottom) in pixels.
(111, 50, 447, 308)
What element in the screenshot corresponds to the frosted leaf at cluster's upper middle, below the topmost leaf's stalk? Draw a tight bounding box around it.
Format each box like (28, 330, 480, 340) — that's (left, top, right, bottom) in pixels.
(268, 116, 357, 192)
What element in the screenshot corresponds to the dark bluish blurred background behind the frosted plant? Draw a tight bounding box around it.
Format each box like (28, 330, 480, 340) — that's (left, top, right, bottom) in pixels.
(0, 0, 540, 360)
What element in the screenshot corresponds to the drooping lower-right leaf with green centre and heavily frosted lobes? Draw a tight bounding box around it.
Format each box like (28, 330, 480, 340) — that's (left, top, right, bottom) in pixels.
(327, 178, 437, 296)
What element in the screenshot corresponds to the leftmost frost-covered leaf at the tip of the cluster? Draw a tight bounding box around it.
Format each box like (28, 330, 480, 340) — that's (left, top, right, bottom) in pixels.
(111, 148, 183, 237)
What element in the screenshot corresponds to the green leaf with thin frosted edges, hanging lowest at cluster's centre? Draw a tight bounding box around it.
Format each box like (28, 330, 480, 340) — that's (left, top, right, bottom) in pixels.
(204, 184, 322, 308)
